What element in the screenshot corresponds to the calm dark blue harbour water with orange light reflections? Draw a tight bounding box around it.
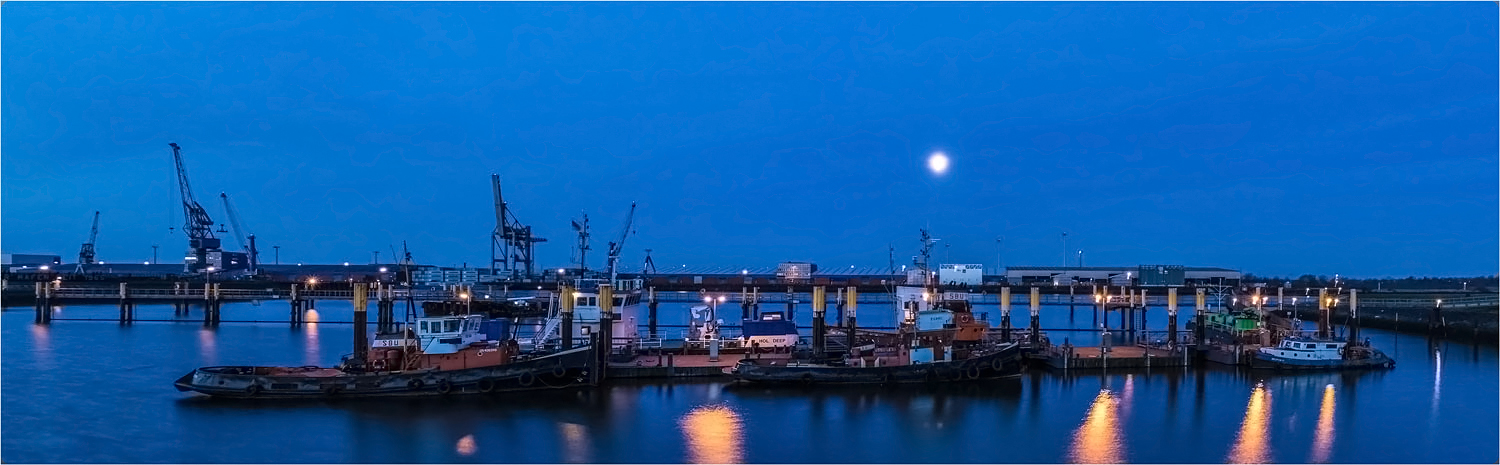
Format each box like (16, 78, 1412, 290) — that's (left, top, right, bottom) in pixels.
(0, 302, 1500, 464)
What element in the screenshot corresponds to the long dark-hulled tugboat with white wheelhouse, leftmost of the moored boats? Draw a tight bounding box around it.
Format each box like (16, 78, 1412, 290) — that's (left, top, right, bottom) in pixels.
(174, 284, 596, 399)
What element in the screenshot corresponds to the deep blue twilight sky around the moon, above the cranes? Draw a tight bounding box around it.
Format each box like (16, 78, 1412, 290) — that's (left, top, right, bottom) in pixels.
(0, 2, 1500, 276)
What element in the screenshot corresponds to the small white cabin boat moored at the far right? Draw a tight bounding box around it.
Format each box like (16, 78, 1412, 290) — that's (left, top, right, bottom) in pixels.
(1251, 336, 1395, 369)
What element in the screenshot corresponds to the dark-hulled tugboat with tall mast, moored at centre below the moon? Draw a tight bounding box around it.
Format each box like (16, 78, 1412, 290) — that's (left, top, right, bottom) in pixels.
(734, 231, 1020, 384)
